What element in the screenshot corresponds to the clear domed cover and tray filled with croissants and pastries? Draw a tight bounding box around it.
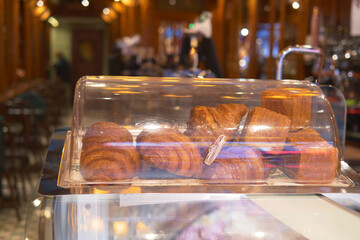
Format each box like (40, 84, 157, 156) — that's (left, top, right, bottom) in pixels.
(58, 76, 352, 188)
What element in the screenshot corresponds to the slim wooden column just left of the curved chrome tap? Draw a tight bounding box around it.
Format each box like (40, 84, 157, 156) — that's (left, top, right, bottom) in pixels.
(247, 0, 258, 78)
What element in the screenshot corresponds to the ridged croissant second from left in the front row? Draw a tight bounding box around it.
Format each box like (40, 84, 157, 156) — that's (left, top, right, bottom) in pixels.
(136, 128, 203, 177)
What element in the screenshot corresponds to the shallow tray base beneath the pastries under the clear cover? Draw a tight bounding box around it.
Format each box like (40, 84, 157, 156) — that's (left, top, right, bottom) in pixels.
(57, 131, 360, 193)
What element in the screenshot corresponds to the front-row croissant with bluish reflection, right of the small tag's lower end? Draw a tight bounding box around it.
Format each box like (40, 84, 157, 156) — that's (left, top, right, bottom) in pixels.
(201, 146, 266, 182)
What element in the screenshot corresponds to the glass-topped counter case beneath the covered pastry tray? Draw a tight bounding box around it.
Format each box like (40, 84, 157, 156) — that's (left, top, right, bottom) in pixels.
(25, 129, 360, 240)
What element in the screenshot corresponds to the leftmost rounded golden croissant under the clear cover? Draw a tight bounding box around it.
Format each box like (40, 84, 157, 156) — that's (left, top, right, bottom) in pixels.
(80, 122, 140, 181)
